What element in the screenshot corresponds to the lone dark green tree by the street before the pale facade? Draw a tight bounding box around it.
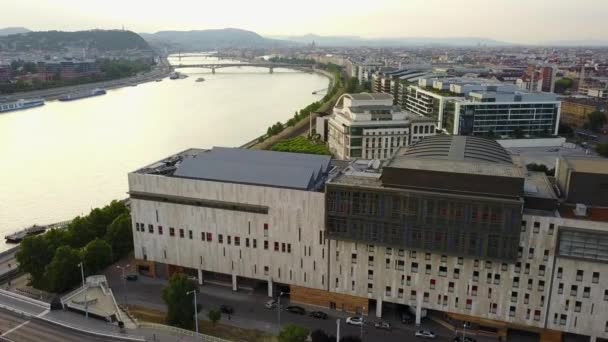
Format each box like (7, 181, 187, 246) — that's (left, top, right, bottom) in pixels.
(161, 273, 197, 329)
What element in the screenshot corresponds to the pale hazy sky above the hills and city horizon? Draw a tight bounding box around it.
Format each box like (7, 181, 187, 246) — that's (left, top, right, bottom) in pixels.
(0, 0, 608, 43)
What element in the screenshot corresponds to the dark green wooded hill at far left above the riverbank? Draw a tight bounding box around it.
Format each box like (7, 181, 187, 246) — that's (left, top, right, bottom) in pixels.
(0, 30, 151, 51)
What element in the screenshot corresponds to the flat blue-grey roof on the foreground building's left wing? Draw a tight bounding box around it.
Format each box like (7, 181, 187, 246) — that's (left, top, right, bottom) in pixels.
(173, 147, 331, 190)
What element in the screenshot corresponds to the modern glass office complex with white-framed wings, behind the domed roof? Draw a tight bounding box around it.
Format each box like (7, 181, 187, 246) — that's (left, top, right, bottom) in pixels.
(405, 78, 561, 136)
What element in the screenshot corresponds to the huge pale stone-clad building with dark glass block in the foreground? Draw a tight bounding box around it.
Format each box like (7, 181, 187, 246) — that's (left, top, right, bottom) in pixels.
(129, 140, 608, 342)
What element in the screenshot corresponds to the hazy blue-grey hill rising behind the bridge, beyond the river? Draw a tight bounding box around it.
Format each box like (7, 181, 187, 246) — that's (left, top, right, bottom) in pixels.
(140, 28, 288, 51)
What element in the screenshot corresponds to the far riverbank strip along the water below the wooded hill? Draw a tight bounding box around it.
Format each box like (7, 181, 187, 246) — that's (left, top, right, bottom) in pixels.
(0, 59, 171, 102)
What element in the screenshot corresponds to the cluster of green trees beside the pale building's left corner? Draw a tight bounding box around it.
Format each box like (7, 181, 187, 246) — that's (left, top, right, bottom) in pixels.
(16, 201, 133, 293)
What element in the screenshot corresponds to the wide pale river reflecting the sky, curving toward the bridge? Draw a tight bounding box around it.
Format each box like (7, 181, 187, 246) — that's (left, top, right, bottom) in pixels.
(0, 54, 328, 250)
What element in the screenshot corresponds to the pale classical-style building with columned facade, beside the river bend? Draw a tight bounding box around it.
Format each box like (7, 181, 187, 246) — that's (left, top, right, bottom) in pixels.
(326, 93, 435, 159)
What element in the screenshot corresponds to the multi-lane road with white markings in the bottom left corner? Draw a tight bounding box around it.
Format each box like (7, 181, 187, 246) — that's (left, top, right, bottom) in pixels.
(0, 310, 133, 342)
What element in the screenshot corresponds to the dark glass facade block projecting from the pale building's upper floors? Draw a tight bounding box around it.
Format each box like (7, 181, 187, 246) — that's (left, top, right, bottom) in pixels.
(326, 184, 521, 261)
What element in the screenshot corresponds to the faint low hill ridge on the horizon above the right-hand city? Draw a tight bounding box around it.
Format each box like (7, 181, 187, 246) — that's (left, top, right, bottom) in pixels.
(275, 34, 511, 47)
